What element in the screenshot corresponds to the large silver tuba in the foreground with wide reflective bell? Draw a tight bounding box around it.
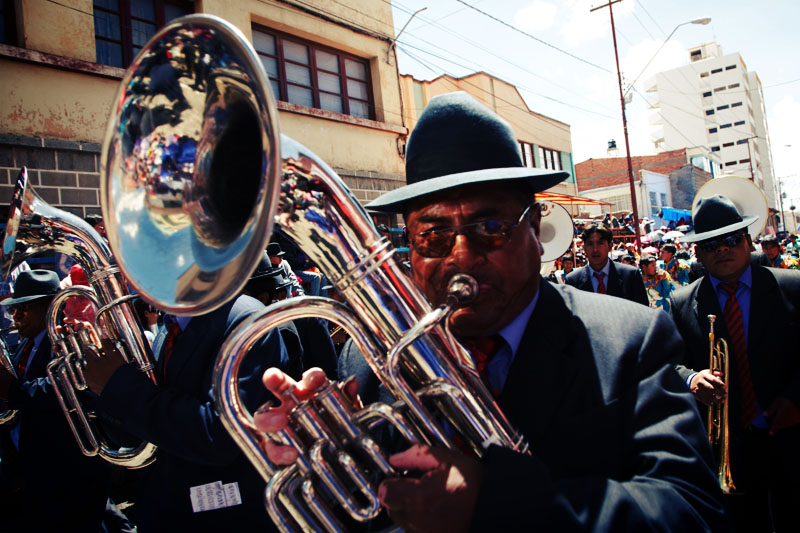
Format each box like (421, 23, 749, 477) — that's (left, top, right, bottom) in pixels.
(101, 15, 527, 531)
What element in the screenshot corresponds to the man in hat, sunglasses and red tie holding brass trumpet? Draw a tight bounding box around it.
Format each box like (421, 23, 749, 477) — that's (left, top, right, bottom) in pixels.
(673, 195, 800, 533)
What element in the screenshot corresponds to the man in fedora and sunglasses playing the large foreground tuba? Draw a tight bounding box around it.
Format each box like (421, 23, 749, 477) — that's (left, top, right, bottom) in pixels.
(256, 93, 728, 531)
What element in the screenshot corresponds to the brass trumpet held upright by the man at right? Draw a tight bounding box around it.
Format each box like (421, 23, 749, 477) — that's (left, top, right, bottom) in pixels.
(708, 315, 736, 494)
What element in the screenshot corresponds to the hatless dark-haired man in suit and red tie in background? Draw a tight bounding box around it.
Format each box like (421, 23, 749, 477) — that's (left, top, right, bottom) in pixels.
(567, 224, 650, 305)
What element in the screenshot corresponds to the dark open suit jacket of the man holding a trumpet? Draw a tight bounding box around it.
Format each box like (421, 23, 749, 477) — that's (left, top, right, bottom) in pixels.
(672, 266, 800, 481)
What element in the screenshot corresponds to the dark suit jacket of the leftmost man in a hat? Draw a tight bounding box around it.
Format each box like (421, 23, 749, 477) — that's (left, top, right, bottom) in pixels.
(0, 335, 111, 532)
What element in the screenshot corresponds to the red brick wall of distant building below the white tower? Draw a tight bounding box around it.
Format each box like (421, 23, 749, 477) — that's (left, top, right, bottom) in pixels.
(575, 149, 687, 191)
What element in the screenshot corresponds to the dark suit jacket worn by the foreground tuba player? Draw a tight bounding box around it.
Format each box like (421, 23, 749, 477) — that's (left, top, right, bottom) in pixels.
(340, 280, 729, 532)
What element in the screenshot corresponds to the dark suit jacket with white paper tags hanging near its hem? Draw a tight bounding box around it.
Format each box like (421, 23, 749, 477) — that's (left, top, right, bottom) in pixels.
(100, 296, 288, 532)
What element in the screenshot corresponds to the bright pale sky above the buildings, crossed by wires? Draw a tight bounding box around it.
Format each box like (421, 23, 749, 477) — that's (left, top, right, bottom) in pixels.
(392, 0, 800, 210)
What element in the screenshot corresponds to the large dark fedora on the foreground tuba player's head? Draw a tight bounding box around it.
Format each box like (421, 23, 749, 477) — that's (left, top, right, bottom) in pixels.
(367, 92, 569, 213)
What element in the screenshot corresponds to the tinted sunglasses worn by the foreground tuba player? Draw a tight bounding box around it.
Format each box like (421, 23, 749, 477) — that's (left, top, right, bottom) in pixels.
(409, 203, 537, 257)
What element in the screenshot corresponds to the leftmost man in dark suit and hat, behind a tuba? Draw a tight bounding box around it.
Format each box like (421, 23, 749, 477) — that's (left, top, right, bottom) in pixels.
(0, 270, 110, 532)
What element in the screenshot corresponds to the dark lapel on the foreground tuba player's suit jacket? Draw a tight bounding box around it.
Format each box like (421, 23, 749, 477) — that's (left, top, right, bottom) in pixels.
(500, 280, 577, 441)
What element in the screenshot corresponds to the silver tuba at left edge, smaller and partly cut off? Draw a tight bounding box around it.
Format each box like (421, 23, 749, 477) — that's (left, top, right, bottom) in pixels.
(2, 168, 156, 468)
